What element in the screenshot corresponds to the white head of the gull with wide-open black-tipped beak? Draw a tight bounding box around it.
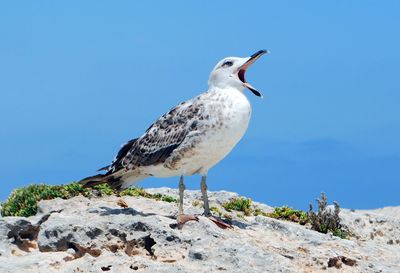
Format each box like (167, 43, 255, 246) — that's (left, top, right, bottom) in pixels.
(208, 50, 267, 97)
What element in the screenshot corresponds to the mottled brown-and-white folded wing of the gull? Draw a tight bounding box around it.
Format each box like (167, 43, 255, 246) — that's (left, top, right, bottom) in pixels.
(110, 100, 202, 172)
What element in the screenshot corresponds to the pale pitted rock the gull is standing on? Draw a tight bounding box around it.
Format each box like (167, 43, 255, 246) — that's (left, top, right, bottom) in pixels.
(0, 188, 400, 273)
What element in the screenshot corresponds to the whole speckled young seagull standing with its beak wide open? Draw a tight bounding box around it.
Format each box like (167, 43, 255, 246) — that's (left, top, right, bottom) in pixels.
(80, 50, 268, 228)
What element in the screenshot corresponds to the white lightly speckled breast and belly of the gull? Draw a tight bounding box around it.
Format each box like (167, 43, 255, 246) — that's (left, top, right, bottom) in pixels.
(146, 89, 251, 177)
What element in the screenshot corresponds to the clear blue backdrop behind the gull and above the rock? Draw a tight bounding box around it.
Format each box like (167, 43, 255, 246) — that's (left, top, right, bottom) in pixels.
(0, 0, 400, 209)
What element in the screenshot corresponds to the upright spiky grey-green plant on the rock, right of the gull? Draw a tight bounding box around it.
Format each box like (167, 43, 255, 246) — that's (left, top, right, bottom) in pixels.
(308, 193, 349, 239)
